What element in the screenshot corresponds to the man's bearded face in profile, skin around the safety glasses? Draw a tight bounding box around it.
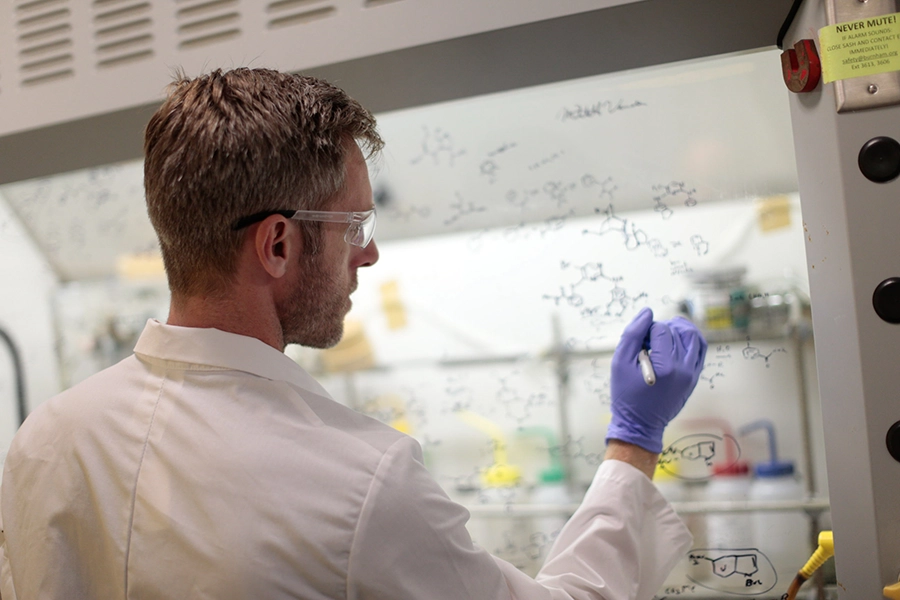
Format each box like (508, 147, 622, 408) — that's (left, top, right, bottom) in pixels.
(278, 143, 378, 348)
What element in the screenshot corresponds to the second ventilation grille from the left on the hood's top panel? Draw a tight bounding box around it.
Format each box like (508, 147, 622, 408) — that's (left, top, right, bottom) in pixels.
(93, 0, 153, 67)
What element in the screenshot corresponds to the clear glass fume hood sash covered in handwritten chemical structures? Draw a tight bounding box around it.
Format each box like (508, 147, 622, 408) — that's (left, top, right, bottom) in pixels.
(0, 45, 830, 598)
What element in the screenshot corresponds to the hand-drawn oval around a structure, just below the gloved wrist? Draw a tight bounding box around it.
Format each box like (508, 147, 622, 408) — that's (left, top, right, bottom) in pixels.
(659, 433, 741, 481)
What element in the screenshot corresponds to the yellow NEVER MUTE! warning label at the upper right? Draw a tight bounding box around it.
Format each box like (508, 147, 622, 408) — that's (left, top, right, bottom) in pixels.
(819, 13, 900, 83)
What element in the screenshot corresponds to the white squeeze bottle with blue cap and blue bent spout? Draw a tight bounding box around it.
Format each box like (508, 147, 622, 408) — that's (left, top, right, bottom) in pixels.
(741, 419, 813, 581)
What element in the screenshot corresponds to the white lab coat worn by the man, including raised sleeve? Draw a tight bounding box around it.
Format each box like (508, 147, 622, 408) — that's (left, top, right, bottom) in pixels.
(0, 321, 690, 600)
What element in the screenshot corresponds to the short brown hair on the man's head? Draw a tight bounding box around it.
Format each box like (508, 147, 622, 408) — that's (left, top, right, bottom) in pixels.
(144, 68, 384, 296)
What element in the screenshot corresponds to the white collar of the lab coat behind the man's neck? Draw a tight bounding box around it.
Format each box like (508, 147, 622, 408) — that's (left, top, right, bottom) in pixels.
(134, 319, 331, 398)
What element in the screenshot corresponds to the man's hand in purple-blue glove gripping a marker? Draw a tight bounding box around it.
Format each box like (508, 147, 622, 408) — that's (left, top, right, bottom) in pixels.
(606, 308, 706, 453)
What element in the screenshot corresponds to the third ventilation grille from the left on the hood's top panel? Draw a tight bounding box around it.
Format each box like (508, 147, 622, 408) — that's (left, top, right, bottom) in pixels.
(175, 0, 241, 48)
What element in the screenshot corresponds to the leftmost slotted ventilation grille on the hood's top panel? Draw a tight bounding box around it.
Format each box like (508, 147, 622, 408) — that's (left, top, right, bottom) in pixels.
(15, 0, 75, 85)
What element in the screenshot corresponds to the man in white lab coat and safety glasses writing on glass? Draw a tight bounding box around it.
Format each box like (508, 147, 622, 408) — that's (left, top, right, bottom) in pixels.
(0, 69, 706, 600)
